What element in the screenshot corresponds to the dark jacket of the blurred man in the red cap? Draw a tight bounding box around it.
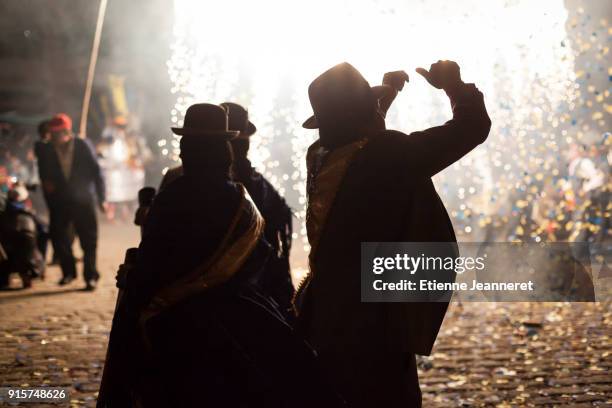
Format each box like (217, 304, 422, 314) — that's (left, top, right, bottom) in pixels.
(36, 138, 106, 211)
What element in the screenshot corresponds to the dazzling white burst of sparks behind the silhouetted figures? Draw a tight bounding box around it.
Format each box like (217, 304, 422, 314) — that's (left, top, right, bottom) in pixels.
(165, 0, 610, 274)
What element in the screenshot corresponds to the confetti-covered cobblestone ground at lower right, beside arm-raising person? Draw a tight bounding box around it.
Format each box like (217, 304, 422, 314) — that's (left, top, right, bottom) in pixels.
(420, 303, 612, 407)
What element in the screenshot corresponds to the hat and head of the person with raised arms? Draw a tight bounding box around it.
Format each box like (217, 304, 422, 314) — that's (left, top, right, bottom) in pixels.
(302, 62, 388, 148)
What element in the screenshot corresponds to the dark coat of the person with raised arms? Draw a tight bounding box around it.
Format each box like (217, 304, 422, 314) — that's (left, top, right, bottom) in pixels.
(300, 85, 491, 354)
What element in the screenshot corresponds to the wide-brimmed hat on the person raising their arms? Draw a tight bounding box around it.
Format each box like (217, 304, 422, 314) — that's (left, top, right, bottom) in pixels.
(302, 62, 393, 129)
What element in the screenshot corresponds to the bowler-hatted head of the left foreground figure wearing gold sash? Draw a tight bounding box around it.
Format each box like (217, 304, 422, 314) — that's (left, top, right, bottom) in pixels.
(172, 103, 239, 176)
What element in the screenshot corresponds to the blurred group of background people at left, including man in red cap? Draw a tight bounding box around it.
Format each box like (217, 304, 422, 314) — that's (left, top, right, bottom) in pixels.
(0, 114, 151, 290)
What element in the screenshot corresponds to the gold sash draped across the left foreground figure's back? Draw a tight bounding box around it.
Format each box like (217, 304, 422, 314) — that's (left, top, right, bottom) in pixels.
(140, 184, 264, 341)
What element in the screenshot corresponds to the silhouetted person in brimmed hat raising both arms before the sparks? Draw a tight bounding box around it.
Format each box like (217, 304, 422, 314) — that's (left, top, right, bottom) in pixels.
(297, 61, 491, 407)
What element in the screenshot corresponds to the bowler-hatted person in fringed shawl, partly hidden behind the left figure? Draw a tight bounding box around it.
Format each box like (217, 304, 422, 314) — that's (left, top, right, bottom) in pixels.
(221, 102, 293, 312)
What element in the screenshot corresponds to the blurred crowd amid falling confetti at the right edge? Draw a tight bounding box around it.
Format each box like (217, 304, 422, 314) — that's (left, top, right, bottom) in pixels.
(451, 134, 612, 247)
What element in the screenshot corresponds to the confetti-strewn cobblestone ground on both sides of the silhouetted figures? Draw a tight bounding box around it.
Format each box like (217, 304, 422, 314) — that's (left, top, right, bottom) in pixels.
(0, 225, 612, 407)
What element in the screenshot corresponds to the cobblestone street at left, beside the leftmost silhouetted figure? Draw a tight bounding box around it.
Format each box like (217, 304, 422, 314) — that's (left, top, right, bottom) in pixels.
(0, 224, 139, 407)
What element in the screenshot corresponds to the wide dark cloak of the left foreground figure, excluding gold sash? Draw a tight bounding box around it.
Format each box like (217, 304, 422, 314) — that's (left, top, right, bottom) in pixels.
(111, 174, 341, 407)
